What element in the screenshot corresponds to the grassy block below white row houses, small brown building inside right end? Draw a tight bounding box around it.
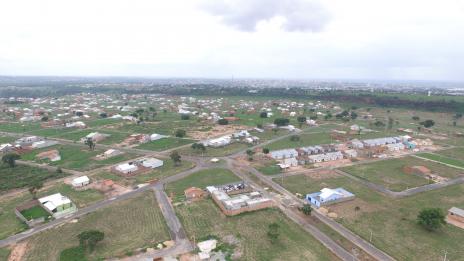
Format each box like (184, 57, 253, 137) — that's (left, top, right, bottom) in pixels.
(341, 157, 462, 191)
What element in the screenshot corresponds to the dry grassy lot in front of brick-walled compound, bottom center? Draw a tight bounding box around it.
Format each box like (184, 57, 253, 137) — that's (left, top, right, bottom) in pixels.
(176, 199, 336, 260)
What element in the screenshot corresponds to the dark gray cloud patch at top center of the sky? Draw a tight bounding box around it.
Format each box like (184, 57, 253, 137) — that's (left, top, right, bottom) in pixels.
(202, 0, 330, 32)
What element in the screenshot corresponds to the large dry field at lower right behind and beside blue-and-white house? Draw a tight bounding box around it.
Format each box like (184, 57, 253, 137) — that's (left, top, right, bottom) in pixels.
(275, 173, 464, 260)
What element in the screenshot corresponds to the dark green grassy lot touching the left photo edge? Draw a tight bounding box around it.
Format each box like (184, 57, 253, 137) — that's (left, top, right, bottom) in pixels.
(0, 163, 67, 192)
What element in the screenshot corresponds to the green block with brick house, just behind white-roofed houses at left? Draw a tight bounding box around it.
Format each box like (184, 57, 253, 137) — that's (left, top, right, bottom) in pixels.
(21, 145, 137, 170)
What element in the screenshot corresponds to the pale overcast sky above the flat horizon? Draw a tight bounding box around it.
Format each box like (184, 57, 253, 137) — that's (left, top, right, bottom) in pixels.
(0, 0, 464, 81)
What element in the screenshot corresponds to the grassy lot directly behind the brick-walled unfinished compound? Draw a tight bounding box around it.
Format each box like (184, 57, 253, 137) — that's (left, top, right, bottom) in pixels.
(166, 169, 240, 199)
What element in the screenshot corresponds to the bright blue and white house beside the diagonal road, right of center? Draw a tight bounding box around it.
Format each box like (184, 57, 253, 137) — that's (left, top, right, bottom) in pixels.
(306, 188, 355, 208)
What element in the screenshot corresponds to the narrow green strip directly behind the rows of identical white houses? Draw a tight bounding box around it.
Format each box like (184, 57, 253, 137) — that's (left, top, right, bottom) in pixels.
(266, 132, 335, 150)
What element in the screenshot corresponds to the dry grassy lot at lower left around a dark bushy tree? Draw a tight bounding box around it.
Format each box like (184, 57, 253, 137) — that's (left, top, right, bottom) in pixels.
(24, 192, 169, 260)
